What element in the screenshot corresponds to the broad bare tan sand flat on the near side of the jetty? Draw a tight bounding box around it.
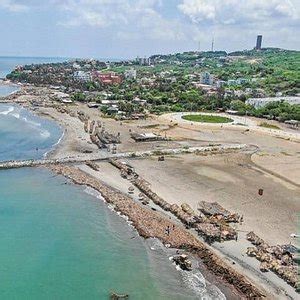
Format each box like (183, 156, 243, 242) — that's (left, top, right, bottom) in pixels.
(129, 153, 300, 244)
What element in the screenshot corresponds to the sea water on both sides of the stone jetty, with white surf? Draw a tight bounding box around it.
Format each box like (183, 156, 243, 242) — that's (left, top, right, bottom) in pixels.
(0, 58, 223, 300)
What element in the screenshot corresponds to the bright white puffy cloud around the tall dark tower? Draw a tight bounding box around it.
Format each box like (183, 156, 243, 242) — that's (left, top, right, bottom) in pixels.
(177, 0, 300, 49)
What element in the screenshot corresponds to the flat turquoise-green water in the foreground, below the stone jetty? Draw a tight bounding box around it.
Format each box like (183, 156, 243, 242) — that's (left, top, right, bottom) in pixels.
(0, 169, 192, 299)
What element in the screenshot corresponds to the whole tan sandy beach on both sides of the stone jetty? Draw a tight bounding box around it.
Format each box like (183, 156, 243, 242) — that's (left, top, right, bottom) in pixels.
(1, 85, 300, 299)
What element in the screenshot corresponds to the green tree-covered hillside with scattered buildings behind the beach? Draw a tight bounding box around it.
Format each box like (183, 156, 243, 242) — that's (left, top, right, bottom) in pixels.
(7, 48, 300, 122)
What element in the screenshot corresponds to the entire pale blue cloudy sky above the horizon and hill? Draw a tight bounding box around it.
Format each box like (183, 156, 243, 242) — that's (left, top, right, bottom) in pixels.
(0, 0, 300, 58)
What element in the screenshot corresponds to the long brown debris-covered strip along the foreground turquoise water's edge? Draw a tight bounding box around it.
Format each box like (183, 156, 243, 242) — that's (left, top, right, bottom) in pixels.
(48, 165, 265, 299)
